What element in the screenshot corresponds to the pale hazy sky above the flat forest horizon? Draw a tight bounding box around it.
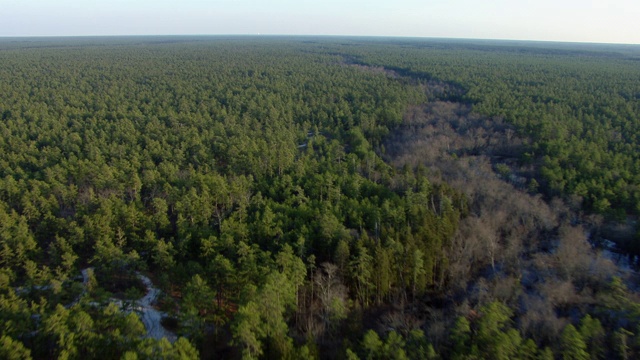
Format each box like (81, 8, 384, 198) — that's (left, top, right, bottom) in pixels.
(0, 0, 640, 44)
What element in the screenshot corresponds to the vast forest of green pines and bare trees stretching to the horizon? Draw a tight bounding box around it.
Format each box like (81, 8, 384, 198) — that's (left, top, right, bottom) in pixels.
(0, 37, 640, 359)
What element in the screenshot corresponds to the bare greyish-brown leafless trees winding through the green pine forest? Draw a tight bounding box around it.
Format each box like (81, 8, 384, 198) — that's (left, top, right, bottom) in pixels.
(384, 97, 616, 344)
